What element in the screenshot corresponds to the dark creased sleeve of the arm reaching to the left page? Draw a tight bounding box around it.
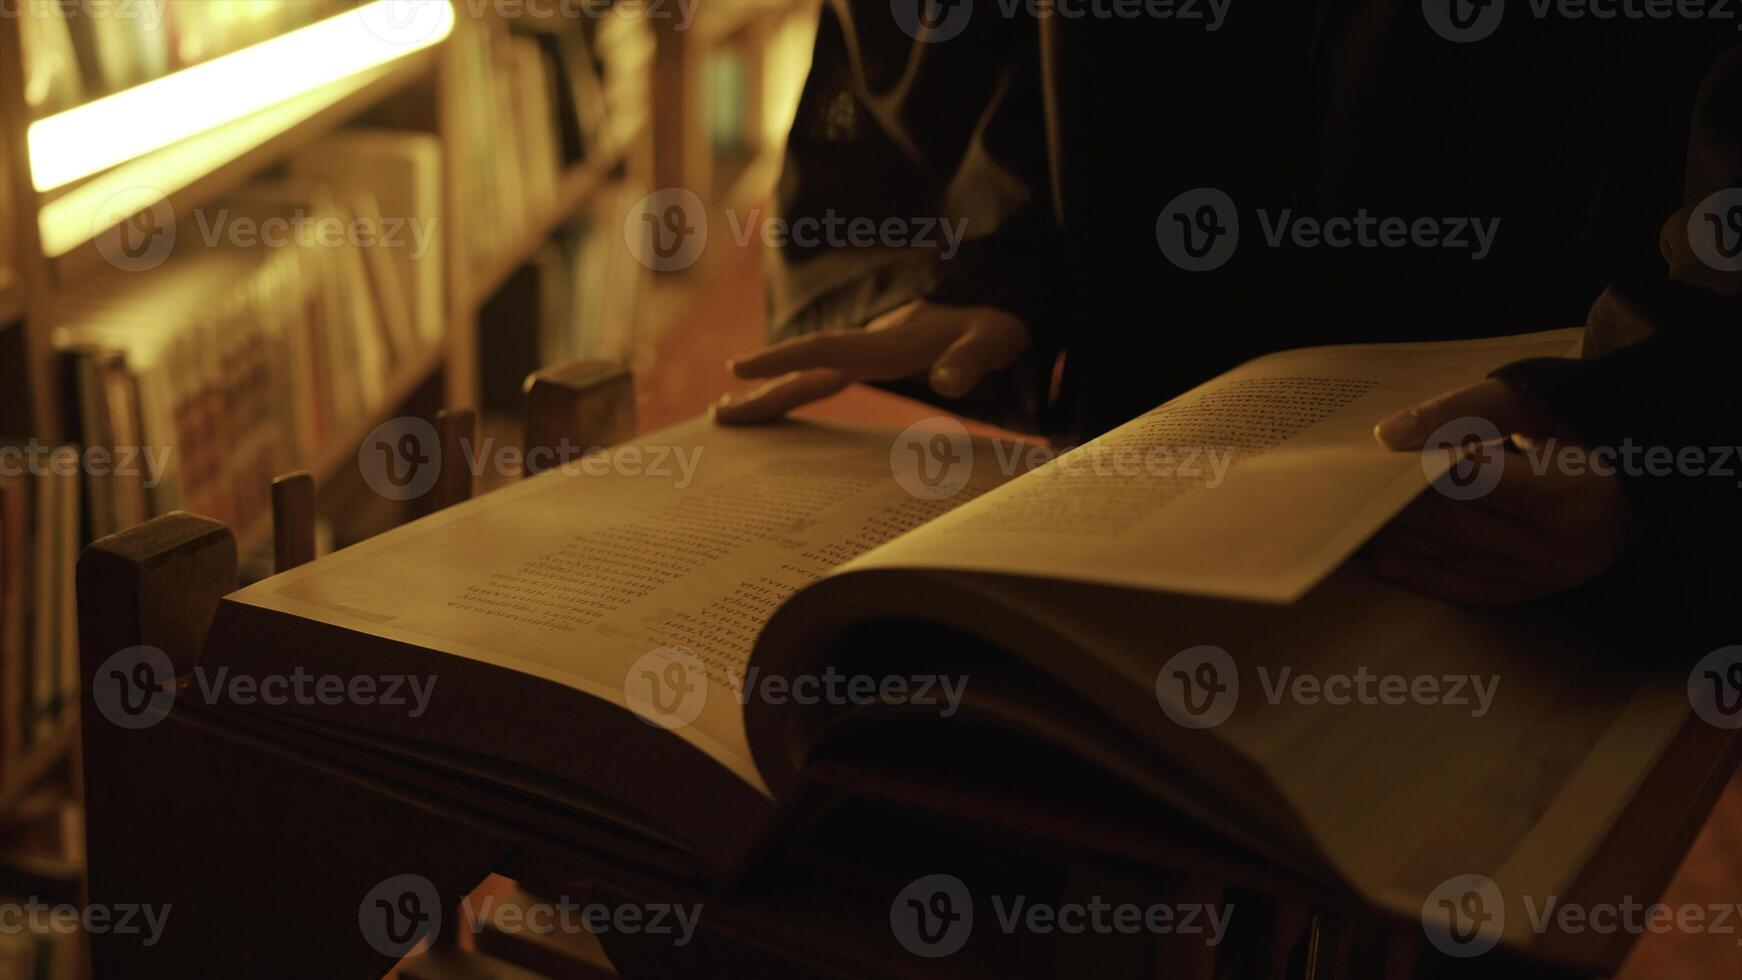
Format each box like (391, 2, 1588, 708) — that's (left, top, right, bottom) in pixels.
(768, 0, 1064, 428)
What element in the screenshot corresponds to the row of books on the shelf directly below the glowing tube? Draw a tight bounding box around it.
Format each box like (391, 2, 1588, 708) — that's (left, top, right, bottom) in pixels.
(51, 131, 444, 536)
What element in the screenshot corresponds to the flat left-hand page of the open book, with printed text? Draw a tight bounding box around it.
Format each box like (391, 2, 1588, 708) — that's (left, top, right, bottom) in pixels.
(230, 420, 998, 792)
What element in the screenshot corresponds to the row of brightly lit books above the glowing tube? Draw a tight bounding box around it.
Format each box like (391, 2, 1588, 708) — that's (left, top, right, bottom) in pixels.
(17, 0, 357, 118)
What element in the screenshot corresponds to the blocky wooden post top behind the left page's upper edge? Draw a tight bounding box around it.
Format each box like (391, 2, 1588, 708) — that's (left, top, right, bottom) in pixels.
(523, 359, 636, 477)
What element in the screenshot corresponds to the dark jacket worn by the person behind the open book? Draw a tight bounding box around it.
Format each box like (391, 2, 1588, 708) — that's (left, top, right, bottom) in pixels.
(770, 0, 1742, 626)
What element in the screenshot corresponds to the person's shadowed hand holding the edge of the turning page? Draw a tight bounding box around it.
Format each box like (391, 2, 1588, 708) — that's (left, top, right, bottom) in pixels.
(1369, 381, 1634, 606)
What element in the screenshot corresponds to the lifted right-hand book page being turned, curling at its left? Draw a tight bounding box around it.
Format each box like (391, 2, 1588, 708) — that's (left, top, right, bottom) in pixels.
(852, 329, 1580, 602)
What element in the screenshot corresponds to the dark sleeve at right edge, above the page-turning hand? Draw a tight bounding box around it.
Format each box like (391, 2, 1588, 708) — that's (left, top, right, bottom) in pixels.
(1496, 49, 1742, 627)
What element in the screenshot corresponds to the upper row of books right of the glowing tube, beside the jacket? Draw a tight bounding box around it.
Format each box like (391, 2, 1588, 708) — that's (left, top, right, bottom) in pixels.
(455, 16, 655, 275)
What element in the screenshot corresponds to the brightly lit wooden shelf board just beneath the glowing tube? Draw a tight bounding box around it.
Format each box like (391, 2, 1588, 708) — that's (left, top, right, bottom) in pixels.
(40, 45, 441, 284)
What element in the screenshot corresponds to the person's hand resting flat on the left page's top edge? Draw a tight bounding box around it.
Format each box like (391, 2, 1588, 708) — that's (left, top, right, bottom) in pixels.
(714, 301, 1030, 425)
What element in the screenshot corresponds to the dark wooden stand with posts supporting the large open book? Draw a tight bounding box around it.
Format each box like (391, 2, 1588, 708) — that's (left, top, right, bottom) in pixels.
(78, 366, 1735, 980)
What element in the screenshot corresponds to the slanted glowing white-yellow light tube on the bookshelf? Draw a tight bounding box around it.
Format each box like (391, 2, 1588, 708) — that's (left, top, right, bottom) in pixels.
(28, 0, 455, 191)
